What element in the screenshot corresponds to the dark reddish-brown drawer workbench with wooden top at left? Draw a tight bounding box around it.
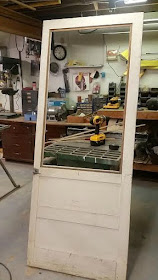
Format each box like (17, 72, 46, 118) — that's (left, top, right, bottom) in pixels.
(0, 117, 92, 163)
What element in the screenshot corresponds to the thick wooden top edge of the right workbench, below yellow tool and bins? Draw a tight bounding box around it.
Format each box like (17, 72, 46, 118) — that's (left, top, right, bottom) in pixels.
(98, 107, 158, 120)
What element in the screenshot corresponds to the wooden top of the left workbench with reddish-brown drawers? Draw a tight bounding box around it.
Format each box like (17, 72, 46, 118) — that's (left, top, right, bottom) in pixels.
(0, 116, 93, 127)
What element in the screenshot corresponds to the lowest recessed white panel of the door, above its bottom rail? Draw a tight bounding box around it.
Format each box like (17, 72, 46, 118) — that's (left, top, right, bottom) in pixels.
(35, 219, 118, 260)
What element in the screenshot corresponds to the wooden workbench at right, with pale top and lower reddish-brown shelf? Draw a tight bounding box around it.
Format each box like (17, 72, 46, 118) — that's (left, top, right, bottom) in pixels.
(98, 107, 158, 172)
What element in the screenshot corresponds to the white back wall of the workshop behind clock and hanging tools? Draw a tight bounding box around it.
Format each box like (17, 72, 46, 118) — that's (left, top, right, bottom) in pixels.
(0, 29, 158, 111)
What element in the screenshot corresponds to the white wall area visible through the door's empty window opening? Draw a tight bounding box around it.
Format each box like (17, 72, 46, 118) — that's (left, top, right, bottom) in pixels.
(49, 32, 128, 102)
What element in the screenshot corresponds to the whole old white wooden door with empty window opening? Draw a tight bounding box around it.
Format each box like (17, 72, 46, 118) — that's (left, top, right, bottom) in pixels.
(28, 13, 143, 280)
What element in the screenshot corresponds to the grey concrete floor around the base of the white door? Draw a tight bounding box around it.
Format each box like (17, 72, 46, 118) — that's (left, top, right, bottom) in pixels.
(0, 162, 158, 280)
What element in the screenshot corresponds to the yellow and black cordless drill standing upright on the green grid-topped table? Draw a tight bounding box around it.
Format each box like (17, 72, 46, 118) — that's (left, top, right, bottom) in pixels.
(90, 116, 106, 146)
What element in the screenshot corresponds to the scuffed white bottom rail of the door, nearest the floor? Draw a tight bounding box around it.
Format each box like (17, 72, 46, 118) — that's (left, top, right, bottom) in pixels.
(31, 247, 116, 280)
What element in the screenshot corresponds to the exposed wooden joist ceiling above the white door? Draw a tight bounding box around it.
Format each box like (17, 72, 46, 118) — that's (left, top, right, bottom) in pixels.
(0, 0, 158, 20)
